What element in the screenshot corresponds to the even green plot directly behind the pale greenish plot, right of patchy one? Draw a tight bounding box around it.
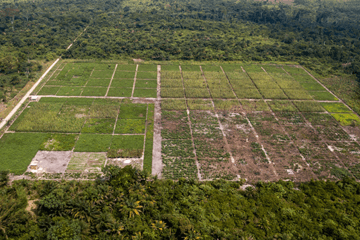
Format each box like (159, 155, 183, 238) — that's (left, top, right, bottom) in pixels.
(74, 134, 112, 152)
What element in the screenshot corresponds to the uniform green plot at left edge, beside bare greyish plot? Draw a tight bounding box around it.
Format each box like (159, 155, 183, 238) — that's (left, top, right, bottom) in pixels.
(0, 133, 47, 175)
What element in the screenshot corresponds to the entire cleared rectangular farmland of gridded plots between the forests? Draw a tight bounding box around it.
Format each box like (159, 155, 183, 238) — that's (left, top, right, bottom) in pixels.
(0, 62, 360, 182)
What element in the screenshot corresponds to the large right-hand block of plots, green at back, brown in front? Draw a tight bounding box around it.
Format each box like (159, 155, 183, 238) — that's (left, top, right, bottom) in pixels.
(161, 65, 360, 182)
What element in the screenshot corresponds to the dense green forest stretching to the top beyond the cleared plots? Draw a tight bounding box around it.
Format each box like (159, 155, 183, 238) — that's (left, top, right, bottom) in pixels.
(0, 0, 360, 100)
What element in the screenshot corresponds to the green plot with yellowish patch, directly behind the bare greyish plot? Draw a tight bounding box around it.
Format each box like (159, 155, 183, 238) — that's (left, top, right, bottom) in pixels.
(39, 134, 79, 151)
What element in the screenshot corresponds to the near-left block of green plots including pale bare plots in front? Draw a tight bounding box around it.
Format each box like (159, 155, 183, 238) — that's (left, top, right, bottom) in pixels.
(0, 97, 154, 176)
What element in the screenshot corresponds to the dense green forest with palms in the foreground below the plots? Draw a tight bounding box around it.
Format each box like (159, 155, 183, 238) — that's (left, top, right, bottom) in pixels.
(0, 166, 360, 240)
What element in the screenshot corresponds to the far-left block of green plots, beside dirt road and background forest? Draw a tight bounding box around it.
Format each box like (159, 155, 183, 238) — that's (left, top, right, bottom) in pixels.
(36, 63, 157, 98)
